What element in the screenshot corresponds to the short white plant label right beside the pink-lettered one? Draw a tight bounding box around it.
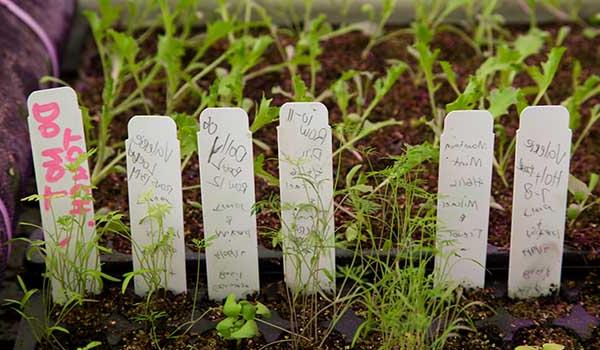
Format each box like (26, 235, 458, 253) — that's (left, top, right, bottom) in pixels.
(125, 116, 186, 295)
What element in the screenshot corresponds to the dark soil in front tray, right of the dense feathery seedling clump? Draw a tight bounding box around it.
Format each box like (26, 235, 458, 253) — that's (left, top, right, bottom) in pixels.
(446, 273, 600, 350)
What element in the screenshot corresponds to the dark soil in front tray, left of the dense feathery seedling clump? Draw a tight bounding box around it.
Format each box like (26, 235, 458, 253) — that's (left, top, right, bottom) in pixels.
(38, 282, 370, 350)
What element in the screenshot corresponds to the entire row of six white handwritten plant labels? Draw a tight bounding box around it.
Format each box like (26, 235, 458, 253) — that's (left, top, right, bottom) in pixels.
(28, 87, 571, 302)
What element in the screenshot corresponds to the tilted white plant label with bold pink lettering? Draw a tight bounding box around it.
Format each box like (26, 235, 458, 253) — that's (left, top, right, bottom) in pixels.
(27, 87, 99, 303)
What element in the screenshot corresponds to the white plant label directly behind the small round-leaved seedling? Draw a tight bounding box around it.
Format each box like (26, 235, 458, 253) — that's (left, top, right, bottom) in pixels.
(198, 108, 260, 300)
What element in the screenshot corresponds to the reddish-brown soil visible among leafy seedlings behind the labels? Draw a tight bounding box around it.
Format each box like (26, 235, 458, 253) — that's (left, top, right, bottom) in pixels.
(64, 25, 600, 258)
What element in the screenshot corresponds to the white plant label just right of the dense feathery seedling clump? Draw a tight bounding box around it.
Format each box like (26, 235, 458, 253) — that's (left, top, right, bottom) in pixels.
(435, 111, 494, 288)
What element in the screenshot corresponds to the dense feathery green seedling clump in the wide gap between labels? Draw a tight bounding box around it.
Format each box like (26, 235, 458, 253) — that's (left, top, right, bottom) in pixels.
(340, 144, 470, 349)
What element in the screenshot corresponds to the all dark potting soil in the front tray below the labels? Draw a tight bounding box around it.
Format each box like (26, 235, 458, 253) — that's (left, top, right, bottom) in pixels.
(21, 273, 600, 350)
